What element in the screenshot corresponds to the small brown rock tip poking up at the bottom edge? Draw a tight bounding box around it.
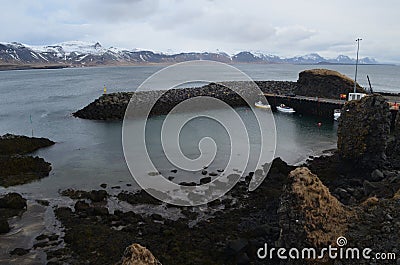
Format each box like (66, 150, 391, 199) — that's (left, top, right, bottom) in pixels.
(117, 244, 161, 265)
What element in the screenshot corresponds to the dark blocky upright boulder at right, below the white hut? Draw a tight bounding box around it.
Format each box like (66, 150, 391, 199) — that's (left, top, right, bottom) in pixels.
(337, 94, 391, 169)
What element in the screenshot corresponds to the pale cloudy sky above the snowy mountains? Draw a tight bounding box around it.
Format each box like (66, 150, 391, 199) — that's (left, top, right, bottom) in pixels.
(0, 0, 400, 63)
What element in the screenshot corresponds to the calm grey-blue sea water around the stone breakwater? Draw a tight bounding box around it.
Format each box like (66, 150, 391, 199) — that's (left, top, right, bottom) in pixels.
(0, 64, 400, 198)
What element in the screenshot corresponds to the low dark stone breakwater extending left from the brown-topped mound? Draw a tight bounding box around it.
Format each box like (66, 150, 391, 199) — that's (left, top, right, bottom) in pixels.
(73, 81, 297, 120)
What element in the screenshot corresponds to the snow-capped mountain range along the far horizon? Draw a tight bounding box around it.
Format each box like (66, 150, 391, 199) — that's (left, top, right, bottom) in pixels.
(0, 41, 378, 66)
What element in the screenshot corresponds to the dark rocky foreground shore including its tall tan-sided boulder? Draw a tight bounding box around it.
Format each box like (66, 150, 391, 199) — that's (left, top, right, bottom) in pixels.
(26, 150, 400, 264)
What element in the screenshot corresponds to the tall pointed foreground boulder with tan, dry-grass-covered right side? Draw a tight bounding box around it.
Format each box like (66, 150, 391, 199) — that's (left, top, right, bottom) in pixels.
(278, 167, 352, 248)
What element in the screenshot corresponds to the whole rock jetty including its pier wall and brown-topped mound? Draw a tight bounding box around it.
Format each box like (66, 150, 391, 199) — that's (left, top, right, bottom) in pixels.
(73, 69, 376, 120)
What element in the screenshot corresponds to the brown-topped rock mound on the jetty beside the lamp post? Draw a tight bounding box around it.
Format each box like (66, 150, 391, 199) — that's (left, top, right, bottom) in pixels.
(296, 69, 365, 99)
